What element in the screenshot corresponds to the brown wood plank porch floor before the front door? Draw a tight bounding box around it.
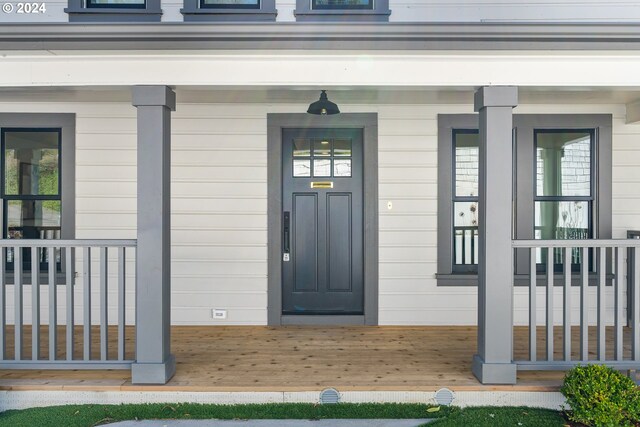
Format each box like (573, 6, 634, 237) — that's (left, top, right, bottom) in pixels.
(0, 326, 580, 391)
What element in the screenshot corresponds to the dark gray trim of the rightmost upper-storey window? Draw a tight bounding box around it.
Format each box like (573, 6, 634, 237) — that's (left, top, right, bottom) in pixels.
(293, 0, 391, 22)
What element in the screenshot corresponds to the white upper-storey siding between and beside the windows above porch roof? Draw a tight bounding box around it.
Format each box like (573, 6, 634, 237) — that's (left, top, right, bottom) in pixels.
(0, 0, 640, 25)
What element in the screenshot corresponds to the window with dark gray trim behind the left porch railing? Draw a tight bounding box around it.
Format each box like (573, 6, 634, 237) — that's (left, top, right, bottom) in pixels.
(0, 113, 75, 280)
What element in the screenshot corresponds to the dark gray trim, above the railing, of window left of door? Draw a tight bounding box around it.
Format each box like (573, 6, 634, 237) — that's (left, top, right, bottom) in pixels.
(0, 113, 76, 244)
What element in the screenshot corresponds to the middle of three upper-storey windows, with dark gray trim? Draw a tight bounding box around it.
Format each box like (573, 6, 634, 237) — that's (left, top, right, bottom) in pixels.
(180, 0, 278, 22)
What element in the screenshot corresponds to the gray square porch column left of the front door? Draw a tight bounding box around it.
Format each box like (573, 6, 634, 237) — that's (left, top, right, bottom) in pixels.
(131, 86, 176, 384)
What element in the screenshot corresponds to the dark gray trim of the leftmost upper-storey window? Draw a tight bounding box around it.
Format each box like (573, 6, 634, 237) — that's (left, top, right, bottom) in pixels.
(64, 0, 162, 22)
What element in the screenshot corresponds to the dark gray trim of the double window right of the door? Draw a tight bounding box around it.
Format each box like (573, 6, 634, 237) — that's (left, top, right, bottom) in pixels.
(436, 114, 613, 286)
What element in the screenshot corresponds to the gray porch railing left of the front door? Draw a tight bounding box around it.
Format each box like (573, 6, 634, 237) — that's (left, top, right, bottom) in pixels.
(0, 239, 136, 369)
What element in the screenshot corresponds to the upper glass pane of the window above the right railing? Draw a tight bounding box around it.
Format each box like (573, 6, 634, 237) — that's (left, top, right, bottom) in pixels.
(535, 131, 592, 196)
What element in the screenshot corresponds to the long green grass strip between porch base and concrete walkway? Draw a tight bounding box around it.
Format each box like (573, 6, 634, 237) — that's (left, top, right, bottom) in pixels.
(0, 403, 455, 427)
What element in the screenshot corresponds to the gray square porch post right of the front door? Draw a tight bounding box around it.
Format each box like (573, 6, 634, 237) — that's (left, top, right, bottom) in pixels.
(473, 86, 518, 384)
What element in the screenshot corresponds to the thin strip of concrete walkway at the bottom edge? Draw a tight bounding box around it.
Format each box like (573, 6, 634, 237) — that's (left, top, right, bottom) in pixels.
(109, 419, 433, 427)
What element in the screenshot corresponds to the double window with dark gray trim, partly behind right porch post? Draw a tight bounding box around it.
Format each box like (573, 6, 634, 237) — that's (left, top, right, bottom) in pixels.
(437, 114, 611, 285)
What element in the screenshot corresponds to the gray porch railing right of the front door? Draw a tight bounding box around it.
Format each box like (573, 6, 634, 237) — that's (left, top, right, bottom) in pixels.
(512, 240, 640, 370)
